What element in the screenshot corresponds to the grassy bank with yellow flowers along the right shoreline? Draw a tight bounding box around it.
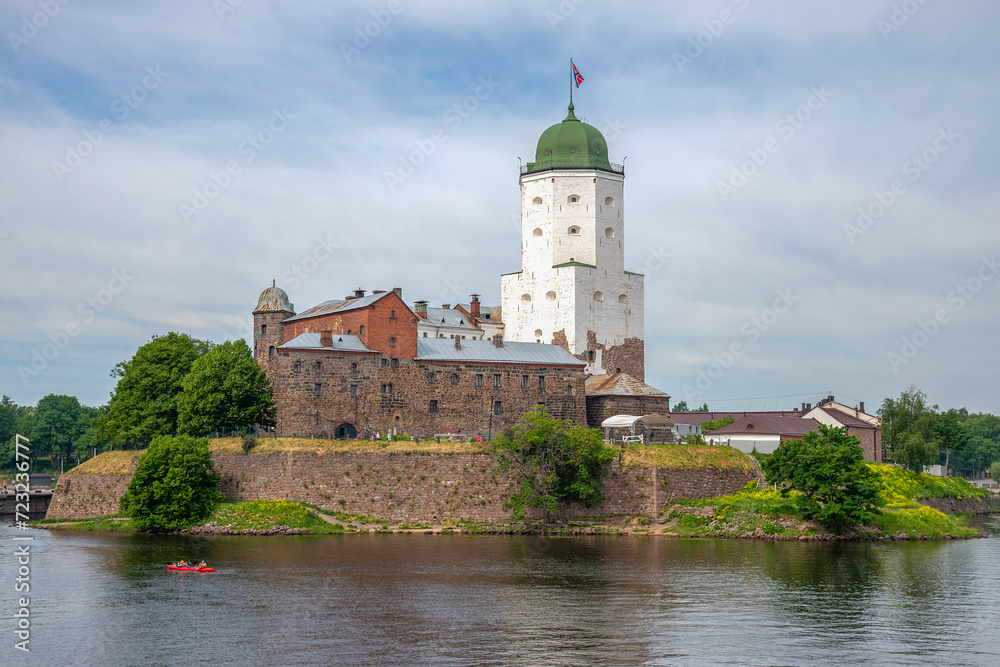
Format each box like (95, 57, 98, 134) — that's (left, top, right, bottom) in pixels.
(660, 464, 987, 539)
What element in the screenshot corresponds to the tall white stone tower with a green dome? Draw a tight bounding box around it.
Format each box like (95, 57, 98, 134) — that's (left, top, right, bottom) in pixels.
(501, 102, 645, 380)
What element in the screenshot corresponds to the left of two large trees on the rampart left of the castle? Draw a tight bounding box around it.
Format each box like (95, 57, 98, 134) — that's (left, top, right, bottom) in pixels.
(98, 332, 211, 444)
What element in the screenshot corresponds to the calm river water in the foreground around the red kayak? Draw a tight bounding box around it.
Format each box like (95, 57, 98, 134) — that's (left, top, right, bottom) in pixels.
(0, 525, 1000, 666)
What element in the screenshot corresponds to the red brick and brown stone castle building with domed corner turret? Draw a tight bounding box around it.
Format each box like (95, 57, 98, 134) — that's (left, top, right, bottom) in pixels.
(253, 286, 586, 438)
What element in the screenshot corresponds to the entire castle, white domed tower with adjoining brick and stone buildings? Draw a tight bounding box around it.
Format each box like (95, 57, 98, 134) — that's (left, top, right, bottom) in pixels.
(253, 102, 670, 438)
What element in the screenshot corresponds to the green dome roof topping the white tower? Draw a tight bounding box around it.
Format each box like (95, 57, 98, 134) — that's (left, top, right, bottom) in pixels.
(522, 102, 621, 173)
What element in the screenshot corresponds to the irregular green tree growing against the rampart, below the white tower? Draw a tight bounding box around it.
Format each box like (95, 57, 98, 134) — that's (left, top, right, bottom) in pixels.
(492, 405, 617, 523)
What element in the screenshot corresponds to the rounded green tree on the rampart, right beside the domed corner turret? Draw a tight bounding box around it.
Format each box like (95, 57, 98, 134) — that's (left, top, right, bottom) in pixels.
(177, 339, 275, 435)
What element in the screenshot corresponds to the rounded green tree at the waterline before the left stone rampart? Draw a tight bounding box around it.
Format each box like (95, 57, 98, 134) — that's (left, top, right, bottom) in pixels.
(120, 435, 222, 532)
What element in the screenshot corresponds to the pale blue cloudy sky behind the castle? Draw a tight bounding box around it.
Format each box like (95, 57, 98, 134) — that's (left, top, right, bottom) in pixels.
(0, 0, 1000, 413)
